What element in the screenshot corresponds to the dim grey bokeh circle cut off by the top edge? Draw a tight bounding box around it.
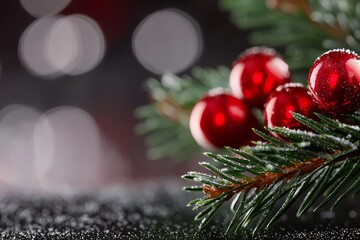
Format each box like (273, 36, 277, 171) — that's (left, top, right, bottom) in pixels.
(20, 0, 71, 17)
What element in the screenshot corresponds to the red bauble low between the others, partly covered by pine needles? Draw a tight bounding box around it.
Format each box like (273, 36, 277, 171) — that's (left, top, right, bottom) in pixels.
(264, 83, 317, 136)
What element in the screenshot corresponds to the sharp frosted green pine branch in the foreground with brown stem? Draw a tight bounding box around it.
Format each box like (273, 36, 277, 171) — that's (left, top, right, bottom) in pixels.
(183, 113, 360, 234)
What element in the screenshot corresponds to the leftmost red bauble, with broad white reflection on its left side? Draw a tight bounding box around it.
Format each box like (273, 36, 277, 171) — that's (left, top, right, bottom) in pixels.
(190, 90, 257, 149)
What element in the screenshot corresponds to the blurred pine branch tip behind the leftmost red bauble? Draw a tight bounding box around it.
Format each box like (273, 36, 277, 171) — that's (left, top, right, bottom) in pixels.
(135, 66, 229, 160)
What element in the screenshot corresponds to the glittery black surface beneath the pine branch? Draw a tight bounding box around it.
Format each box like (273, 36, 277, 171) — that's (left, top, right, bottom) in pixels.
(0, 180, 360, 240)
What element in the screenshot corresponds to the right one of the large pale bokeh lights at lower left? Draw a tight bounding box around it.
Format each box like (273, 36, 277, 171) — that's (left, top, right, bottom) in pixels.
(34, 107, 103, 191)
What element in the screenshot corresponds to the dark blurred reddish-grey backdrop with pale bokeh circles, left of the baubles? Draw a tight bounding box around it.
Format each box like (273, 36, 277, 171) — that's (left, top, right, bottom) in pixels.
(0, 0, 248, 191)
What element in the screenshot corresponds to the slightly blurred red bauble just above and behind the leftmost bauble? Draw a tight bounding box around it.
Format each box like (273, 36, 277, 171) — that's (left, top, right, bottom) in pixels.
(230, 47, 291, 107)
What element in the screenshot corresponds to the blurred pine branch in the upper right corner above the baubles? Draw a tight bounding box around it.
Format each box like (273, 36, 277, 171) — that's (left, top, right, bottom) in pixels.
(219, 0, 360, 83)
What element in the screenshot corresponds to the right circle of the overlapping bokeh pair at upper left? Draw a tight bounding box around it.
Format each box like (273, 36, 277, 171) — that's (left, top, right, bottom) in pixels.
(45, 14, 105, 75)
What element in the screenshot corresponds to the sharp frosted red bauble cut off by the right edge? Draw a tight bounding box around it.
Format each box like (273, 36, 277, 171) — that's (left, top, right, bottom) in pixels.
(308, 49, 360, 114)
